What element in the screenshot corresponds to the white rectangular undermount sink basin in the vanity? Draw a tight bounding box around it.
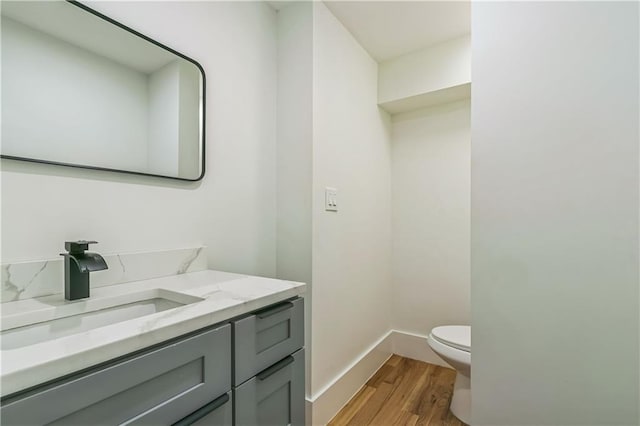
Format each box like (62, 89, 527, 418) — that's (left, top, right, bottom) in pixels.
(0, 289, 203, 351)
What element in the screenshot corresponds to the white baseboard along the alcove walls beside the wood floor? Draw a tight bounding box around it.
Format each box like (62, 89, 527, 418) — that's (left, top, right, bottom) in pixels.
(306, 330, 451, 425)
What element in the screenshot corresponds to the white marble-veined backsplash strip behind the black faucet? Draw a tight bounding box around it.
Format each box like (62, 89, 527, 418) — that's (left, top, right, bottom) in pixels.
(0, 247, 207, 303)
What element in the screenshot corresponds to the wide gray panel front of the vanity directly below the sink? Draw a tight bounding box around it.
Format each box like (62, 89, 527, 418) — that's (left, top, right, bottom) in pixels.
(0, 325, 231, 425)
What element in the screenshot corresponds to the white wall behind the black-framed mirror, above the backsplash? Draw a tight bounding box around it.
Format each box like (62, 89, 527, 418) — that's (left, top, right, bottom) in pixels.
(2, 2, 276, 276)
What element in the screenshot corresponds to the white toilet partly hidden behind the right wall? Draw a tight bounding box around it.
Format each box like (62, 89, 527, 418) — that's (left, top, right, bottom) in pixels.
(427, 325, 471, 424)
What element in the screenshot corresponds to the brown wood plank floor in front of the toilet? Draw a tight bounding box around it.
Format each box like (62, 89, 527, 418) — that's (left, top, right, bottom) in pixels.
(329, 355, 464, 426)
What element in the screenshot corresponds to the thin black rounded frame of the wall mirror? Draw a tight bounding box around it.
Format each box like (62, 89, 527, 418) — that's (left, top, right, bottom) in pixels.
(0, 0, 207, 182)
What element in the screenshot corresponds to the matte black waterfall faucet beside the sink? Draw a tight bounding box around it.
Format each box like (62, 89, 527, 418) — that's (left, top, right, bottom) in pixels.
(60, 240, 108, 300)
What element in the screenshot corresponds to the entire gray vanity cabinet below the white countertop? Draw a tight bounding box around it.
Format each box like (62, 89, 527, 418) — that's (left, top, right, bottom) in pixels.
(0, 298, 305, 426)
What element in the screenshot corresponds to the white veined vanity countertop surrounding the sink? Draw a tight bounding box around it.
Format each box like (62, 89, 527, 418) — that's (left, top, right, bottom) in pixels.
(0, 270, 305, 396)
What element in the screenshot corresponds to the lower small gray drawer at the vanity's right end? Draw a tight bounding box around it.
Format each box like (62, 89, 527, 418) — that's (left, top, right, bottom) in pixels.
(234, 349, 305, 426)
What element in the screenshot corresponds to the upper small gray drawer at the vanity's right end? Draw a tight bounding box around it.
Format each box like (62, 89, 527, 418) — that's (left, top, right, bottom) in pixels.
(233, 298, 304, 385)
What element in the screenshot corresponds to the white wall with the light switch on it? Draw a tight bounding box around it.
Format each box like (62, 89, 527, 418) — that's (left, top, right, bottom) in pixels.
(311, 2, 391, 416)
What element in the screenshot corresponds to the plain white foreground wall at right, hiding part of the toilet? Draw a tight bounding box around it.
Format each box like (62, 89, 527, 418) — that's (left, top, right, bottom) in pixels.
(471, 2, 640, 425)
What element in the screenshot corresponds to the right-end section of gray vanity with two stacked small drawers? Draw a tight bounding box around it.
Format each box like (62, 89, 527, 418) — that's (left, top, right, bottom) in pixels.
(232, 298, 305, 426)
